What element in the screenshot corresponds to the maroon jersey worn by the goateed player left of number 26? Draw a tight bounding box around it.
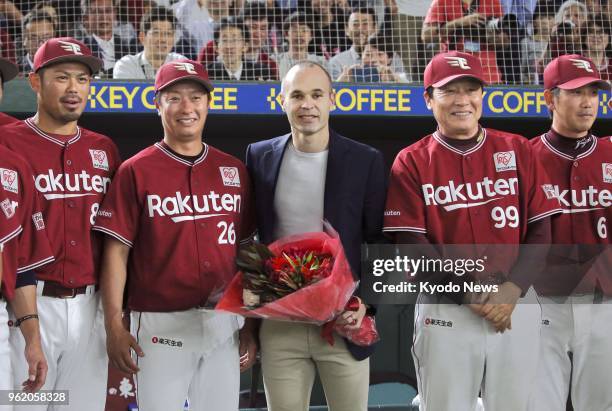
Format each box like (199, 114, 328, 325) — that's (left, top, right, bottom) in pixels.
(0, 119, 120, 288)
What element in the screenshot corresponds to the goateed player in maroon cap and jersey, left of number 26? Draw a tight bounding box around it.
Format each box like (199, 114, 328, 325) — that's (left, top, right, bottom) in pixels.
(0, 37, 119, 410)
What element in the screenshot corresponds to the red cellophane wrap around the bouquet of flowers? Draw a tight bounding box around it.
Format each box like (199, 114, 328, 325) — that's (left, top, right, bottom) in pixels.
(215, 233, 356, 325)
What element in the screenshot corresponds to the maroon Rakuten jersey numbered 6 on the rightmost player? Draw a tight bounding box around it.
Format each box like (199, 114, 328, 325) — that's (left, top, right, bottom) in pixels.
(531, 135, 612, 295)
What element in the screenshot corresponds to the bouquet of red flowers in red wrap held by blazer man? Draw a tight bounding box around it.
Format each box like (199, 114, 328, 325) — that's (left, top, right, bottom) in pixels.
(216, 233, 356, 325)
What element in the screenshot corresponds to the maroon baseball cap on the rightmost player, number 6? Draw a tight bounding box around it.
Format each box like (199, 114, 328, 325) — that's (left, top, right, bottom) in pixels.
(544, 54, 610, 90)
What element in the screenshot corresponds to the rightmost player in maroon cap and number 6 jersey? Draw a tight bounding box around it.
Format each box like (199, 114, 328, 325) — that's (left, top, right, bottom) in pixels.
(530, 54, 612, 411)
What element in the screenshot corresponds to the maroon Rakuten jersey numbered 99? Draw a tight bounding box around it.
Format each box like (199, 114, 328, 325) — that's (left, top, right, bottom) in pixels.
(383, 129, 560, 273)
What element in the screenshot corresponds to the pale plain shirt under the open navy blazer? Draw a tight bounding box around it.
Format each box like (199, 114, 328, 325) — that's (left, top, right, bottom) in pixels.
(274, 141, 328, 239)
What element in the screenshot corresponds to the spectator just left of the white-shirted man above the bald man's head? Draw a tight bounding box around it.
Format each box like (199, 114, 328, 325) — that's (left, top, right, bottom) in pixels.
(241, 3, 278, 79)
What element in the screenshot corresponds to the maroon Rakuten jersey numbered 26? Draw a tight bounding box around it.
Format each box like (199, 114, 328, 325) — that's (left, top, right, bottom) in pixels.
(94, 143, 255, 311)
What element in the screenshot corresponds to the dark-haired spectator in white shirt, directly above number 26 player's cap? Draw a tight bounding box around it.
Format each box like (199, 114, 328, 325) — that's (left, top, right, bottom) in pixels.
(113, 7, 185, 80)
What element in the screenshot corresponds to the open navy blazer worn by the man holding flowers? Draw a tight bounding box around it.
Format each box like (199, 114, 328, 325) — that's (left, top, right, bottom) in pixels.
(246, 131, 387, 360)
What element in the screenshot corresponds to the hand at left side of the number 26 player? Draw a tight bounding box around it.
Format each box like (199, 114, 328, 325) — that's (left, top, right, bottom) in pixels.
(106, 322, 144, 374)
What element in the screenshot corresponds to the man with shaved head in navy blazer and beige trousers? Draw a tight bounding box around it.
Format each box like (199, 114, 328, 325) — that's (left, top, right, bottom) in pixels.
(246, 62, 386, 411)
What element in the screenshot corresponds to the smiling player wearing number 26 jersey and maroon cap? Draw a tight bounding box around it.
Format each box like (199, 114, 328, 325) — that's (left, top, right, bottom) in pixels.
(94, 60, 256, 411)
